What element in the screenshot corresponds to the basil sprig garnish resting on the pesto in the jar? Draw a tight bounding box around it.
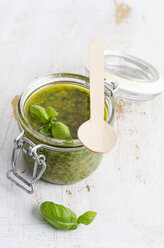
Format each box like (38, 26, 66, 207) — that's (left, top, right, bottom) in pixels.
(30, 104, 72, 140)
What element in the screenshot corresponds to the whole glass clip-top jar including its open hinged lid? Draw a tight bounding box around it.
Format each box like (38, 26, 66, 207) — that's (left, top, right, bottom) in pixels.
(7, 50, 164, 193)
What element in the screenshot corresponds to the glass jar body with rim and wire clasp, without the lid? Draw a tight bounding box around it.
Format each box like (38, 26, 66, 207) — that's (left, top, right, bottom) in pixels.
(7, 73, 117, 193)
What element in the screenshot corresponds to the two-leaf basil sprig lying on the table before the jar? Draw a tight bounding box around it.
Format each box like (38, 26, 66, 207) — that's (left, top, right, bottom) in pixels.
(40, 201, 97, 230)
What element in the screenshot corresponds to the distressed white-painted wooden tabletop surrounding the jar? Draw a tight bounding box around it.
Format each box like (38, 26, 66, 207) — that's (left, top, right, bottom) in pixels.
(0, 0, 164, 248)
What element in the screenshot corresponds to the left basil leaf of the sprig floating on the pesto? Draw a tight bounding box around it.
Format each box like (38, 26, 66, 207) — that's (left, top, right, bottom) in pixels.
(30, 104, 49, 124)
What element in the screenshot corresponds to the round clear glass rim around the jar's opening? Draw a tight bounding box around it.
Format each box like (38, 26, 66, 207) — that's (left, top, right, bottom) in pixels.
(18, 73, 114, 147)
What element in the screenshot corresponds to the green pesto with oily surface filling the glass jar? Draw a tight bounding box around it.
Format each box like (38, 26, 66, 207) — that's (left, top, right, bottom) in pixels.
(24, 82, 108, 184)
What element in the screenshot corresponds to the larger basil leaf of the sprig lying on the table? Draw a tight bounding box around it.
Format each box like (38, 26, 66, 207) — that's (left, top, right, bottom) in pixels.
(40, 201, 78, 230)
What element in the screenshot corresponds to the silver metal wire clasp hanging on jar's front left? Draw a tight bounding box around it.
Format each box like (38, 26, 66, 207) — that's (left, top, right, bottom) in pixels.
(7, 131, 46, 194)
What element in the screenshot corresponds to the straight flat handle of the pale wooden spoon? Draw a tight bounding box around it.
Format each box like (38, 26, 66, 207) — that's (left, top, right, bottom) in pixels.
(89, 40, 104, 122)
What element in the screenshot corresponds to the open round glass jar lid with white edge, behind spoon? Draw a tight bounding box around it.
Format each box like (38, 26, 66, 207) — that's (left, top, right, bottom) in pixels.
(85, 50, 164, 100)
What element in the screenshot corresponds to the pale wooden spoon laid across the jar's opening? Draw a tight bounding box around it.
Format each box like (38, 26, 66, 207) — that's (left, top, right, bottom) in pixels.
(78, 41, 117, 153)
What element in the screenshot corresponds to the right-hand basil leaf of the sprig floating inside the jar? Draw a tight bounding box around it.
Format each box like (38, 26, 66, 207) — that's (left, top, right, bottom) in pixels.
(51, 121, 72, 140)
